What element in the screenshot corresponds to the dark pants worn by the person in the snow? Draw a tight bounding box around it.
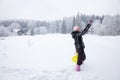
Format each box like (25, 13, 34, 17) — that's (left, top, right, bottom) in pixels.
(76, 49, 86, 65)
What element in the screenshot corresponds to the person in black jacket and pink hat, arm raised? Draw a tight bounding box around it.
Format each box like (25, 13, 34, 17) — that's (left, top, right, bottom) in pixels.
(71, 20, 92, 71)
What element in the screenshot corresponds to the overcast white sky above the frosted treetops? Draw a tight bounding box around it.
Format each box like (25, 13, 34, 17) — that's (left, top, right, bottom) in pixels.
(0, 0, 120, 20)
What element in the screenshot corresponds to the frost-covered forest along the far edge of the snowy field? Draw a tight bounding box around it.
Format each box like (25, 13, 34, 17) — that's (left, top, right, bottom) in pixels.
(0, 13, 120, 37)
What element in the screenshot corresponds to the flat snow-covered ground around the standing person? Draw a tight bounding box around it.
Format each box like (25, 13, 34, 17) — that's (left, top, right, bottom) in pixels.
(0, 34, 120, 80)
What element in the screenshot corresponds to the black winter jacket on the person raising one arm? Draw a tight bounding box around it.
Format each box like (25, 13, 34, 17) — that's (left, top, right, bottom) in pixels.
(71, 24, 91, 49)
